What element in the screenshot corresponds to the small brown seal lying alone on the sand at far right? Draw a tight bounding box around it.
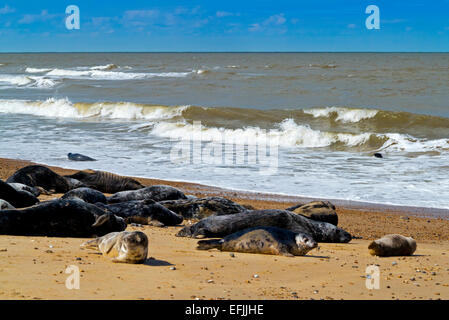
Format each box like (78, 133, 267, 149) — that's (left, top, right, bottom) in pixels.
(368, 234, 416, 257)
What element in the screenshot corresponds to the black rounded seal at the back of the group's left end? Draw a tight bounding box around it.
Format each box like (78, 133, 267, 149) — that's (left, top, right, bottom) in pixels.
(6, 165, 70, 193)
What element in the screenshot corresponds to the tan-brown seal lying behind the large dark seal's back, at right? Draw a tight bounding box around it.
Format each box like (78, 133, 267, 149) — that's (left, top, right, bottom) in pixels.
(285, 201, 338, 226)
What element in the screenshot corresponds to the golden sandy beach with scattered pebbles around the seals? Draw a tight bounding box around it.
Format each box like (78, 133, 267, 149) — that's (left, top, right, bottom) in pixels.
(0, 159, 449, 300)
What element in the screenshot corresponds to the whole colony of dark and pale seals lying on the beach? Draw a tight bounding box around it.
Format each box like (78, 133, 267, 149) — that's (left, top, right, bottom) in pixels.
(0, 165, 416, 263)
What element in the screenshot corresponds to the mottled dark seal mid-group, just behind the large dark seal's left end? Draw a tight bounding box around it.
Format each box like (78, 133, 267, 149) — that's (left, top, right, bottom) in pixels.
(159, 197, 247, 219)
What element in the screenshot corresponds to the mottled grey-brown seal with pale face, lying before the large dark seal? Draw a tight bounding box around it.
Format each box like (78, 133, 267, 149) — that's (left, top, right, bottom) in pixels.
(197, 227, 318, 257)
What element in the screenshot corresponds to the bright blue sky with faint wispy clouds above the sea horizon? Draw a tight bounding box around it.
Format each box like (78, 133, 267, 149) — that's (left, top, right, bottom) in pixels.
(0, 0, 449, 52)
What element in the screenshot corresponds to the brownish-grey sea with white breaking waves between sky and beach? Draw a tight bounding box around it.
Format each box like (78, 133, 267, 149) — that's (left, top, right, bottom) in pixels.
(0, 52, 449, 209)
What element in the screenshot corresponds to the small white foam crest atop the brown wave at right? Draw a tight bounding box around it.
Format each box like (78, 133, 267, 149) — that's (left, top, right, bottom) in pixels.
(303, 107, 379, 123)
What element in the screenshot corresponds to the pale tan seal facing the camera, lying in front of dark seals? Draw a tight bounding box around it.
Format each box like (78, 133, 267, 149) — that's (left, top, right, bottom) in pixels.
(81, 231, 148, 263)
